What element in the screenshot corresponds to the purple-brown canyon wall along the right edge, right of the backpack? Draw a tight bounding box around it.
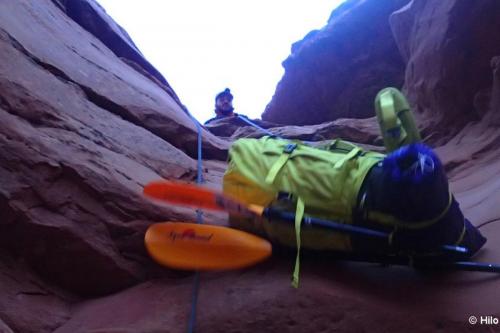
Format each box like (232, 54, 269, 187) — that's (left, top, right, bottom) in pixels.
(390, 0, 500, 249)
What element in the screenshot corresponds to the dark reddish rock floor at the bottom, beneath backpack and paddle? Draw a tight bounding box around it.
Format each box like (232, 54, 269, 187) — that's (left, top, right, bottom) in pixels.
(55, 258, 493, 333)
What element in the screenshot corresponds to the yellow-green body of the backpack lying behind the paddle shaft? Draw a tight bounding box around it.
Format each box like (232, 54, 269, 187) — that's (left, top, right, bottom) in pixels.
(223, 136, 384, 251)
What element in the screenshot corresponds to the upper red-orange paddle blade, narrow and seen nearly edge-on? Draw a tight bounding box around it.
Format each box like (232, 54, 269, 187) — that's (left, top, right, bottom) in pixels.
(144, 181, 255, 217)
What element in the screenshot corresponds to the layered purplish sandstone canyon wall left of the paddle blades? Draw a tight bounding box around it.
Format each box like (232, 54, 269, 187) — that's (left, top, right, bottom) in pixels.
(0, 0, 228, 332)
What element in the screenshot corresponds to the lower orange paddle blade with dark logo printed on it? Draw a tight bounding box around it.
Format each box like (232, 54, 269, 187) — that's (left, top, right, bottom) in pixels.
(145, 222, 272, 270)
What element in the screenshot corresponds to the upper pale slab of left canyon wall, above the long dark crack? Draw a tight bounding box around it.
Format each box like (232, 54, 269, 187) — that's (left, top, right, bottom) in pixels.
(0, 1, 227, 159)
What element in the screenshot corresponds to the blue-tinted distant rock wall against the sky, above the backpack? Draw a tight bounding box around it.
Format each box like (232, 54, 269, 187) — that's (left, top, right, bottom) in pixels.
(262, 0, 408, 125)
